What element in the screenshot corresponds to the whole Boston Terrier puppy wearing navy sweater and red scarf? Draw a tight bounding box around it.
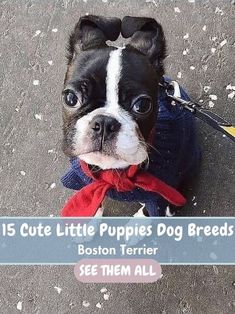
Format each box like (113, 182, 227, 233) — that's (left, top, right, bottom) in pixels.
(61, 15, 200, 217)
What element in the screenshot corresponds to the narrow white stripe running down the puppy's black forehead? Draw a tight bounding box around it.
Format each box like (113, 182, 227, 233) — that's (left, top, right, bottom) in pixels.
(106, 48, 123, 112)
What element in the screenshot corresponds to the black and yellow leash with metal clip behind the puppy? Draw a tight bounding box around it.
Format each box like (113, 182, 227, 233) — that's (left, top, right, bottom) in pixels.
(159, 78, 235, 142)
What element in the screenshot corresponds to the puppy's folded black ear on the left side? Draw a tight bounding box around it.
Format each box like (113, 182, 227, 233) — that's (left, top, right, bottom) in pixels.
(68, 15, 121, 61)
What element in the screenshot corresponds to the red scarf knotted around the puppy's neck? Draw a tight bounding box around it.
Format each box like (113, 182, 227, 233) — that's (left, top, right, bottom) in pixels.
(61, 161, 186, 217)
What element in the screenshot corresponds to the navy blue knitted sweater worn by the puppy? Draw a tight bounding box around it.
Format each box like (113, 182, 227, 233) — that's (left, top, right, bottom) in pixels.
(61, 78, 201, 216)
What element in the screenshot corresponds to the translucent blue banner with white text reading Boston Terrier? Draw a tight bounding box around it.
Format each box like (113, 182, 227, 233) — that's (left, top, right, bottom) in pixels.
(0, 217, 235, 265)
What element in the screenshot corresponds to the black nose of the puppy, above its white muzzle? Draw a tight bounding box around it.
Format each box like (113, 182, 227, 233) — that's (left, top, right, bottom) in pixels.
(91, 115, 121, 140)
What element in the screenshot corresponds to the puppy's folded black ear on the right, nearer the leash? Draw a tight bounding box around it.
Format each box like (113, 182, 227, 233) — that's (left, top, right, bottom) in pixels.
(121, 16, 166, 74)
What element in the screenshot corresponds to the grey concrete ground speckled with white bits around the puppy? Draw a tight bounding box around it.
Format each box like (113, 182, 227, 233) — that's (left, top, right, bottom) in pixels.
(0, 0, 235, 314)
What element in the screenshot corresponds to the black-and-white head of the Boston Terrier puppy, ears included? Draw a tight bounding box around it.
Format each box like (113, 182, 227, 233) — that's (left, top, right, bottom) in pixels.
(63, 16, 165, 169)
